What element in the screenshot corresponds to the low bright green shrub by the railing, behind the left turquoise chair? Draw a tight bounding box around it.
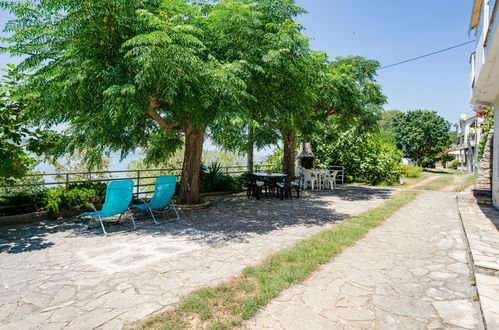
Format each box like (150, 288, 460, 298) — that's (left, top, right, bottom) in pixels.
(42, 183, 106, 218)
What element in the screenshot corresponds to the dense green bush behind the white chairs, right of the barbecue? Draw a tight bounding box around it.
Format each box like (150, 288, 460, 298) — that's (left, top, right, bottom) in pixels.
(312, 121, 402, 184)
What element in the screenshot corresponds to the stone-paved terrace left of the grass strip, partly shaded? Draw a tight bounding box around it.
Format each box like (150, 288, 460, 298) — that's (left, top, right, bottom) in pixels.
(0, 187, 392, 330)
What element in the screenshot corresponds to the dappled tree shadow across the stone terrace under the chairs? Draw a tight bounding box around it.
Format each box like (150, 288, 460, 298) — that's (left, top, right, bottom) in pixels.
(0, 186, 393, 253)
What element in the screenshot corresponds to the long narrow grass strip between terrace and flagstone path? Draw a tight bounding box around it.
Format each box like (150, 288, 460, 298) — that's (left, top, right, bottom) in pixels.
(134, 190, 418, 330)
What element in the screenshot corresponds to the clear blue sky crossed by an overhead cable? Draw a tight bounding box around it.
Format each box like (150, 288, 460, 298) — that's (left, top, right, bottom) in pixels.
(0, 0, 474, 123)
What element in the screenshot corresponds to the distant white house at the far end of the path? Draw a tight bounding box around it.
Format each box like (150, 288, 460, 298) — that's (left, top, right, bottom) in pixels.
(452, 114, 483, 175)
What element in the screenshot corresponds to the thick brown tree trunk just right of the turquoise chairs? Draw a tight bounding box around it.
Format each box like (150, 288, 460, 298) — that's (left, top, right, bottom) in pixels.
(180, 125, 205, 204)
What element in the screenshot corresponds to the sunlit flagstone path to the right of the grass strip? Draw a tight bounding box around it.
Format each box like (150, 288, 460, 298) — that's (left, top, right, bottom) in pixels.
(248, 192, 483, 329)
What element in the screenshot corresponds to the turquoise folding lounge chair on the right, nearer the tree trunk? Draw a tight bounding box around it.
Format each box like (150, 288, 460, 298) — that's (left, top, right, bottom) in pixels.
(130, 175, 180, 225)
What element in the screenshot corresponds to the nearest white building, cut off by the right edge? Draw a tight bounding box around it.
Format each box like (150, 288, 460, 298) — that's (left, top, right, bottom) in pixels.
(470, 0, 499, 207)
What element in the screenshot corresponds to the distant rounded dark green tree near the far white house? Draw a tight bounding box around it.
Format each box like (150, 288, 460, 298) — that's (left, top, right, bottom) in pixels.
(393, 110, 450, 165)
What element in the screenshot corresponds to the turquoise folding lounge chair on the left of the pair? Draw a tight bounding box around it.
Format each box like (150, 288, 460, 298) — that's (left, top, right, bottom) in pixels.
(79, 180, 137, 235)
